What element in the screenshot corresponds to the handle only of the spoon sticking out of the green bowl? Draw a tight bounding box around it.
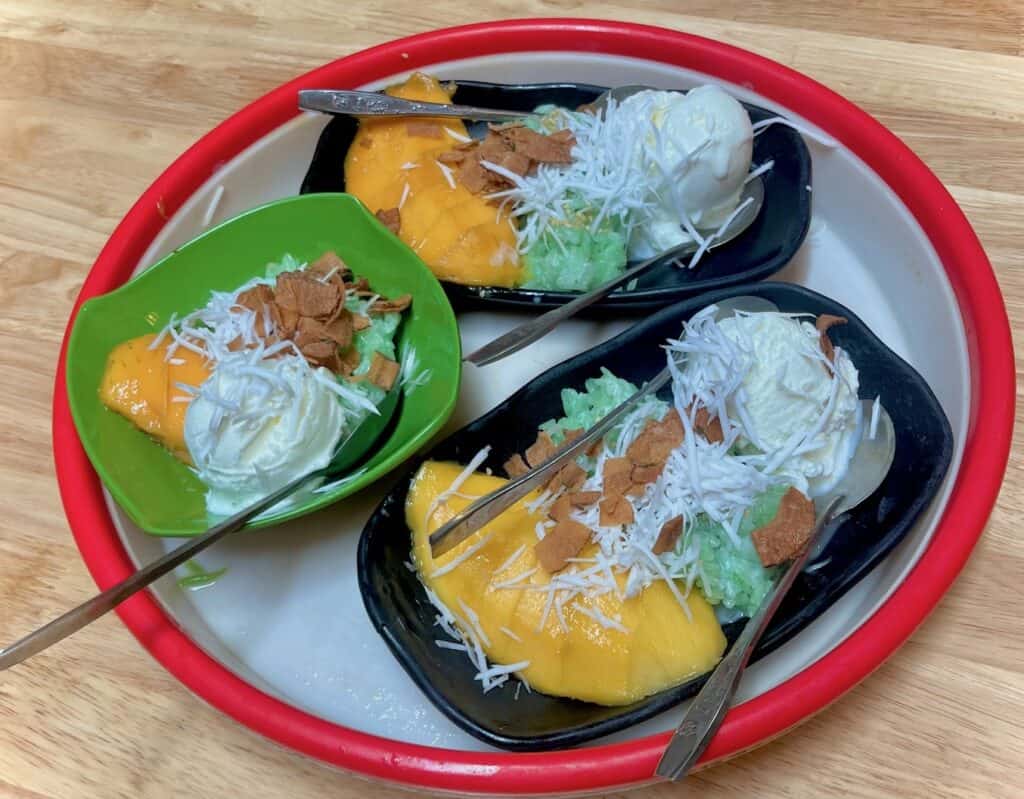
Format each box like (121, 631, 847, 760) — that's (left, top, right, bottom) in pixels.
(0, 470, 324, 671)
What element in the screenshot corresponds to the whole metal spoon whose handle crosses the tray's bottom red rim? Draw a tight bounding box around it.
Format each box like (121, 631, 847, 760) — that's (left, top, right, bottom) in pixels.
(654, 400, 896, 781)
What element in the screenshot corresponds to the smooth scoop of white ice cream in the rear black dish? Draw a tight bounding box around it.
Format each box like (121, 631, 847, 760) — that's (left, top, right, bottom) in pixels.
(622, 85, 754, 259)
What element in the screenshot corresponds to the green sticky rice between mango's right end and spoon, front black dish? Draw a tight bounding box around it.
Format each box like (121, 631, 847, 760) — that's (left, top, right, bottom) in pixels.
(677, 486, 788, 616)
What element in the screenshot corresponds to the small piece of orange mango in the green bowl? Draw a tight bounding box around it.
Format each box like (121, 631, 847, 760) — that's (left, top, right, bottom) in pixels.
(99, 334, 210, 463)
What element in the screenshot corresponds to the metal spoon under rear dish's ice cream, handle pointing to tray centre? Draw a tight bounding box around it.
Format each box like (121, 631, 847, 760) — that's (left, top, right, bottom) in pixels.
(463, 176, 765, 366)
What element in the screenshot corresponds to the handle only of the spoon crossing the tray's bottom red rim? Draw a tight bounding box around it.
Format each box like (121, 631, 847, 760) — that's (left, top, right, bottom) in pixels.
(654, 496, 843, 781)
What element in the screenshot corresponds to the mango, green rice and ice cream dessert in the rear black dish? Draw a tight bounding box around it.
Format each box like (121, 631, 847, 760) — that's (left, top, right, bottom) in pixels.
(345, 73, 754, 291)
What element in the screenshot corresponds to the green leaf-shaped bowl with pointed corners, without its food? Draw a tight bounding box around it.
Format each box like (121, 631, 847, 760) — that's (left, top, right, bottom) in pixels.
(67, 194, 462, 536)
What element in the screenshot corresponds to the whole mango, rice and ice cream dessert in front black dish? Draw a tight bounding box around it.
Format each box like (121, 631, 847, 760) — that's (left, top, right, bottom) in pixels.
(407, 306, 863, 705)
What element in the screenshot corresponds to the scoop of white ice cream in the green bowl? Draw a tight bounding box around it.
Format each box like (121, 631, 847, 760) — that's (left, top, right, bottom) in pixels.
(185, 356, 344, 515)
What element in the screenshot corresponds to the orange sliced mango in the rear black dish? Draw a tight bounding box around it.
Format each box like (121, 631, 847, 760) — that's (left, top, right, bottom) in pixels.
(345, 73, 521, 287)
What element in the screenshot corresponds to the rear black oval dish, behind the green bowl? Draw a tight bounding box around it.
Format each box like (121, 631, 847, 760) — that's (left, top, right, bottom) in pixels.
(300, 81, 811, 316)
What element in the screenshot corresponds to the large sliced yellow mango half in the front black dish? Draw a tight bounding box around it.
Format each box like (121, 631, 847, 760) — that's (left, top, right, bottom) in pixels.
(406, 461, 726, 705)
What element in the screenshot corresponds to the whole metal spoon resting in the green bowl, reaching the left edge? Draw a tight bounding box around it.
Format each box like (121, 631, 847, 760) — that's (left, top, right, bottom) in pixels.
(0, 381, 401, 671)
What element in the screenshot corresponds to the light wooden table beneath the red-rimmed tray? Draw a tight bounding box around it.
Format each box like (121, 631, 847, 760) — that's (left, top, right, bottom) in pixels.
(0, 0, 1024, 799)
